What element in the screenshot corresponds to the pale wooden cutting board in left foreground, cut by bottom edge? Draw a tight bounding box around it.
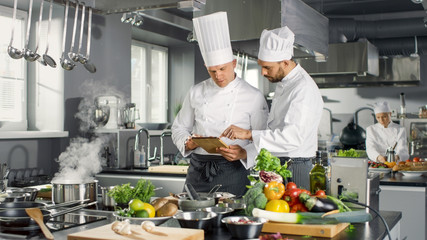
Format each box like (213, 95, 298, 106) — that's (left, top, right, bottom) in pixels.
(67, 224, 205, 240)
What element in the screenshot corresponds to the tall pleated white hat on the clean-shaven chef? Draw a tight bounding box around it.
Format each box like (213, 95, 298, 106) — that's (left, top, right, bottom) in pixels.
(193, 12, 233, 67)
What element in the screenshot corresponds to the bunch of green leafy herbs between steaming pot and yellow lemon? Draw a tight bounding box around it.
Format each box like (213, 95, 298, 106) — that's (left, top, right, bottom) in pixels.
(107, 179, 155, 204)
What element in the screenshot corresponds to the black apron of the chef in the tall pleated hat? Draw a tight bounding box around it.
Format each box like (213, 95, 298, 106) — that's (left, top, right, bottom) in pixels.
(185, 153, 250, 197)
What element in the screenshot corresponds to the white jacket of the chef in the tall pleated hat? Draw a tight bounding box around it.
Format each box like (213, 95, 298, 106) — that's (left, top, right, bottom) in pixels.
(172, 77, 268, 156)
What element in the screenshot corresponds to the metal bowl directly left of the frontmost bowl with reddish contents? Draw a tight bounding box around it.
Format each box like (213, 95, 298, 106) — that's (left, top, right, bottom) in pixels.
(173, 211, 217, 231)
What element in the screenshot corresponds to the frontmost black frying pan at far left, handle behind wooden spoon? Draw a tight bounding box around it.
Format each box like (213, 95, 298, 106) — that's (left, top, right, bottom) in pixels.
(0, 202, 97, 229)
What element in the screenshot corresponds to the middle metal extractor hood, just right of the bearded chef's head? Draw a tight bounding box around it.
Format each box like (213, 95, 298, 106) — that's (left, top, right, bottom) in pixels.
(299, 40, 379, 77)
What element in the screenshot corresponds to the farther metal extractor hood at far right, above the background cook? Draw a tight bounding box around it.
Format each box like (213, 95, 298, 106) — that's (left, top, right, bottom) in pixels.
(313, 56, 421, 88)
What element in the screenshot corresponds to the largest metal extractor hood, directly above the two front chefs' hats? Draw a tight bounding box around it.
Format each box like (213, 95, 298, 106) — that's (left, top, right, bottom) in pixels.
(193, 0, 329, 58)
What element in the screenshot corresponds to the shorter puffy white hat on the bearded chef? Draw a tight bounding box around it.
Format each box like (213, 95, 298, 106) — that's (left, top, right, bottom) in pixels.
(258, 27, 295, 62)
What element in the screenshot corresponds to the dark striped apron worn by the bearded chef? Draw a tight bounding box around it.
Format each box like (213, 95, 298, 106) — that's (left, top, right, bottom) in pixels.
(279, 157, 313, 191)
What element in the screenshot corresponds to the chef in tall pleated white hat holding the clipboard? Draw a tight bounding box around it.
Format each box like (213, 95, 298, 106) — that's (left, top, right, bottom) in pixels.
(172, 12, 268, 196)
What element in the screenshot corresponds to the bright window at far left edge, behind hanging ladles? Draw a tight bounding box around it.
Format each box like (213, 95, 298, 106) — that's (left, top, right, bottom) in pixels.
(0, 6, 27, 131)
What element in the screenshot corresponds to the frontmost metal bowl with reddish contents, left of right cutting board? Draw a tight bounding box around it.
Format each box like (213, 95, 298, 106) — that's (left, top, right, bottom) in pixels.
(222, 216, 267, 239)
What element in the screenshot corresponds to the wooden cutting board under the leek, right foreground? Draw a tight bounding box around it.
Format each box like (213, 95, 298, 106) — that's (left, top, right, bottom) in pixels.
(262, 222, 350, 238)
